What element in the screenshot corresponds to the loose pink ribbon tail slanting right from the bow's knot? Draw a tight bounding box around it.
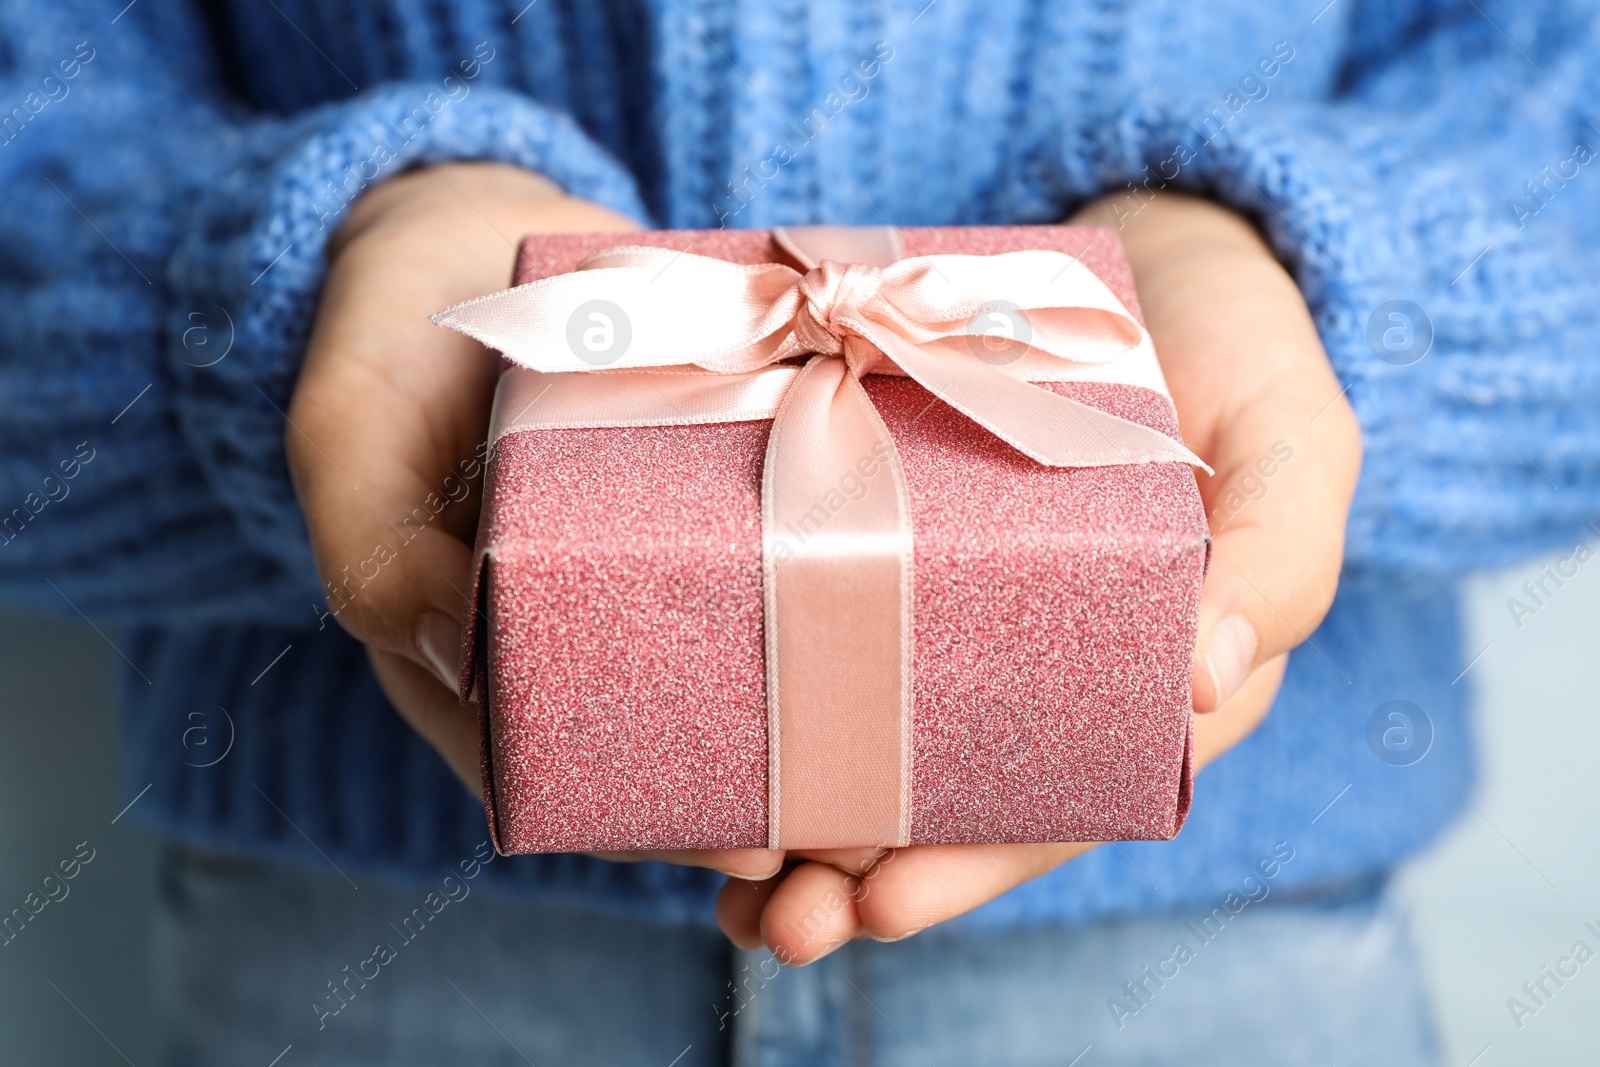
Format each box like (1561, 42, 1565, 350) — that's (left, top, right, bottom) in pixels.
(853, 323, 1211, 474)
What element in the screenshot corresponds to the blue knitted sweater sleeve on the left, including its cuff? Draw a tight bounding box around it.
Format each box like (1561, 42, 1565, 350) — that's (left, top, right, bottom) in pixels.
(0, 0, 646, 622)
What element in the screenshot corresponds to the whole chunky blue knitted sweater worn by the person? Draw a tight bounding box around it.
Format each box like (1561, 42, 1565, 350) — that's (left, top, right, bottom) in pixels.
(0, 0, 1600, 925)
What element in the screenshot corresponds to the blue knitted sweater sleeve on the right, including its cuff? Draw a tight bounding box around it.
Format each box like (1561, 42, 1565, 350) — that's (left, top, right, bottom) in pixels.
(1066, 0, 1600, 573)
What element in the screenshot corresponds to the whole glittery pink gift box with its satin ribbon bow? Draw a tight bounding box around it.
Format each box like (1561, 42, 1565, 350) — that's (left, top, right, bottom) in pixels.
(435, 227, 1210, 853)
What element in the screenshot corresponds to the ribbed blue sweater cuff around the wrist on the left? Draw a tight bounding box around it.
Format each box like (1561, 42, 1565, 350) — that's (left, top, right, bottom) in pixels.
(168, 82, 648, 603)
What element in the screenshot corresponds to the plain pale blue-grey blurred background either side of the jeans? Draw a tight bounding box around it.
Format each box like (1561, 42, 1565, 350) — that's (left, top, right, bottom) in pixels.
(0, 550, 1600, 1067)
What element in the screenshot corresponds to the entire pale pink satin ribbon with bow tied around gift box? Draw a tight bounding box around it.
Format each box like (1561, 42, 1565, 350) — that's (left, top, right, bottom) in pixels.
(432, 227, 1205, 848)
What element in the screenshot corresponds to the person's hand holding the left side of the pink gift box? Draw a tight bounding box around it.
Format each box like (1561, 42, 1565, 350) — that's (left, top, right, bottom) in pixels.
(286, 163, 779, 877)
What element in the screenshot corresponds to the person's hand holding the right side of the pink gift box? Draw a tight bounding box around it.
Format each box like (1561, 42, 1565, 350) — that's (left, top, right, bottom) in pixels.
(717, 194, 1362, 963)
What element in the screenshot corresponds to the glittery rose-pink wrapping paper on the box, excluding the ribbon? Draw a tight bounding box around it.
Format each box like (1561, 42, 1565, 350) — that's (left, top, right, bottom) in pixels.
(466, 227, 1210, 853)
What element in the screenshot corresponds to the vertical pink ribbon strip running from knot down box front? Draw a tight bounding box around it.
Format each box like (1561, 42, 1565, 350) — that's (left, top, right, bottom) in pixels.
(762, 355, 914, 848)
